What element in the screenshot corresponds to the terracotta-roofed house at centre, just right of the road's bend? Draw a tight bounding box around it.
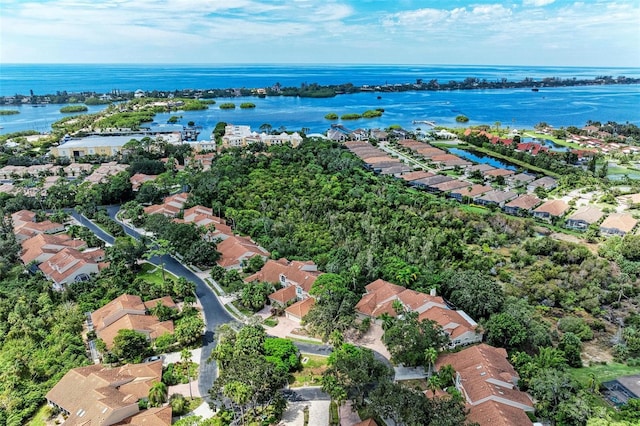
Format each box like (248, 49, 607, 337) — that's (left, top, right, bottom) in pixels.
(244, 258, 322, 305)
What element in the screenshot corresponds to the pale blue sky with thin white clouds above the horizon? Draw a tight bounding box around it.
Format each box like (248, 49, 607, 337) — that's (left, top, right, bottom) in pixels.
(0, 0, 640, 67)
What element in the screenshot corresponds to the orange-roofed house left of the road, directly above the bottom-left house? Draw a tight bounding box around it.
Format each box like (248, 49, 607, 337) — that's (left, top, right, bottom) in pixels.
(91, 294, 176, 349)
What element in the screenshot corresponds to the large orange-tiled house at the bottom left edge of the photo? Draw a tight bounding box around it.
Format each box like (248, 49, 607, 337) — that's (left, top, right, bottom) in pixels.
(46, 360, 171, 426)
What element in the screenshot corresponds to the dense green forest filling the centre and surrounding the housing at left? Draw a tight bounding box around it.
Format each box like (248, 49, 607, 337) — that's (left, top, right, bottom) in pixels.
(0, 140, 640, 425)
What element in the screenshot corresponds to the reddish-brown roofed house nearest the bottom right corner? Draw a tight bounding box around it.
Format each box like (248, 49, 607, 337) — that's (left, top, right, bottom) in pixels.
(436, 343, 534, 426)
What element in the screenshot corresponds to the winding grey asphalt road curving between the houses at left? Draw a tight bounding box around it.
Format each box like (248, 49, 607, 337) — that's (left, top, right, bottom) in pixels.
(71, 206, 235, 395)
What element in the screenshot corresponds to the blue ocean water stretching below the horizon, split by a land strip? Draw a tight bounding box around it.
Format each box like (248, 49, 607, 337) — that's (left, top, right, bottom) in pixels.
(0, 64, 640, 139)
